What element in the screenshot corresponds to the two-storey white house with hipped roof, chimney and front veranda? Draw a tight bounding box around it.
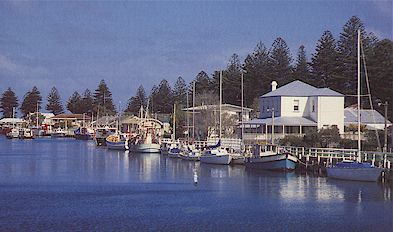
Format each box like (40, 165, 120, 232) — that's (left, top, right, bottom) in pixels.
(245, 80, 344, 141)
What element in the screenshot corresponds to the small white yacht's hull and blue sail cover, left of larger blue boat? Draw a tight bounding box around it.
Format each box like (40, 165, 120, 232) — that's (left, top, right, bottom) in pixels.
(201, 140, 232, 165)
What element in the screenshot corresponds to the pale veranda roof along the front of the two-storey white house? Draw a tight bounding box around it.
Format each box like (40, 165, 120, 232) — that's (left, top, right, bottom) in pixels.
(243, 117, 317, 126)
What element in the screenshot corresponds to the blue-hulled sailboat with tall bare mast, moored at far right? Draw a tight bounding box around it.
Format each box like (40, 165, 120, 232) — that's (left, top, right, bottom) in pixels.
(326, 30, 383, 182)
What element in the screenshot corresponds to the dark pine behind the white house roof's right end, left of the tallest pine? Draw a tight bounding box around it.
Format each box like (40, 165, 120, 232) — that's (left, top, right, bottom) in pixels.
(311, 31, 344, 92)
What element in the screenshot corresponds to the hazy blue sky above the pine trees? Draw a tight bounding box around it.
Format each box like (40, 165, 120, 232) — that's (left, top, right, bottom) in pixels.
(0, 0, 392, 112)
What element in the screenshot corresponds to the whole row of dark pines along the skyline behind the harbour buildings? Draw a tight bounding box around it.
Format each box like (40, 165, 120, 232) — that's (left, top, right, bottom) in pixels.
(0, 16, 393, 120)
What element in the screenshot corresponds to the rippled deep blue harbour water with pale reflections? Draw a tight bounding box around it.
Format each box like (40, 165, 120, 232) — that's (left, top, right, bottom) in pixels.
(0, 137, 393, 231)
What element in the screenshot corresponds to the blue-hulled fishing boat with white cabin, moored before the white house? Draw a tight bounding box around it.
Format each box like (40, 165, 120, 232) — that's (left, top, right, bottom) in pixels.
(244, 145, 299, 171)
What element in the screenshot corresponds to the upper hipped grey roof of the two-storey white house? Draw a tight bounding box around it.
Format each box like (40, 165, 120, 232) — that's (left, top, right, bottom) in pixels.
(261, 80, 344, 97)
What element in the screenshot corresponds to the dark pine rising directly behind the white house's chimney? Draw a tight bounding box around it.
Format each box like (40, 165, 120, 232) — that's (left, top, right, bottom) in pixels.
(269, 37, 292, 85)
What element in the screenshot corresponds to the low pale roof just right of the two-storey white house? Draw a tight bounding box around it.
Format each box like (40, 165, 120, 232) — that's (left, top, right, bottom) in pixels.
(344, 107, 391, 124)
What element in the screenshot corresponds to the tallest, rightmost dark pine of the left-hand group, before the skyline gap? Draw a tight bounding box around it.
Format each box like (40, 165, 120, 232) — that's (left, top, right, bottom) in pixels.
(94, 80, 116, 115)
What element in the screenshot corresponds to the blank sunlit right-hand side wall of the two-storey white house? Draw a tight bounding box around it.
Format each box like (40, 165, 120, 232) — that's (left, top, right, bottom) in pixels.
(317, 96, 344, 134)
